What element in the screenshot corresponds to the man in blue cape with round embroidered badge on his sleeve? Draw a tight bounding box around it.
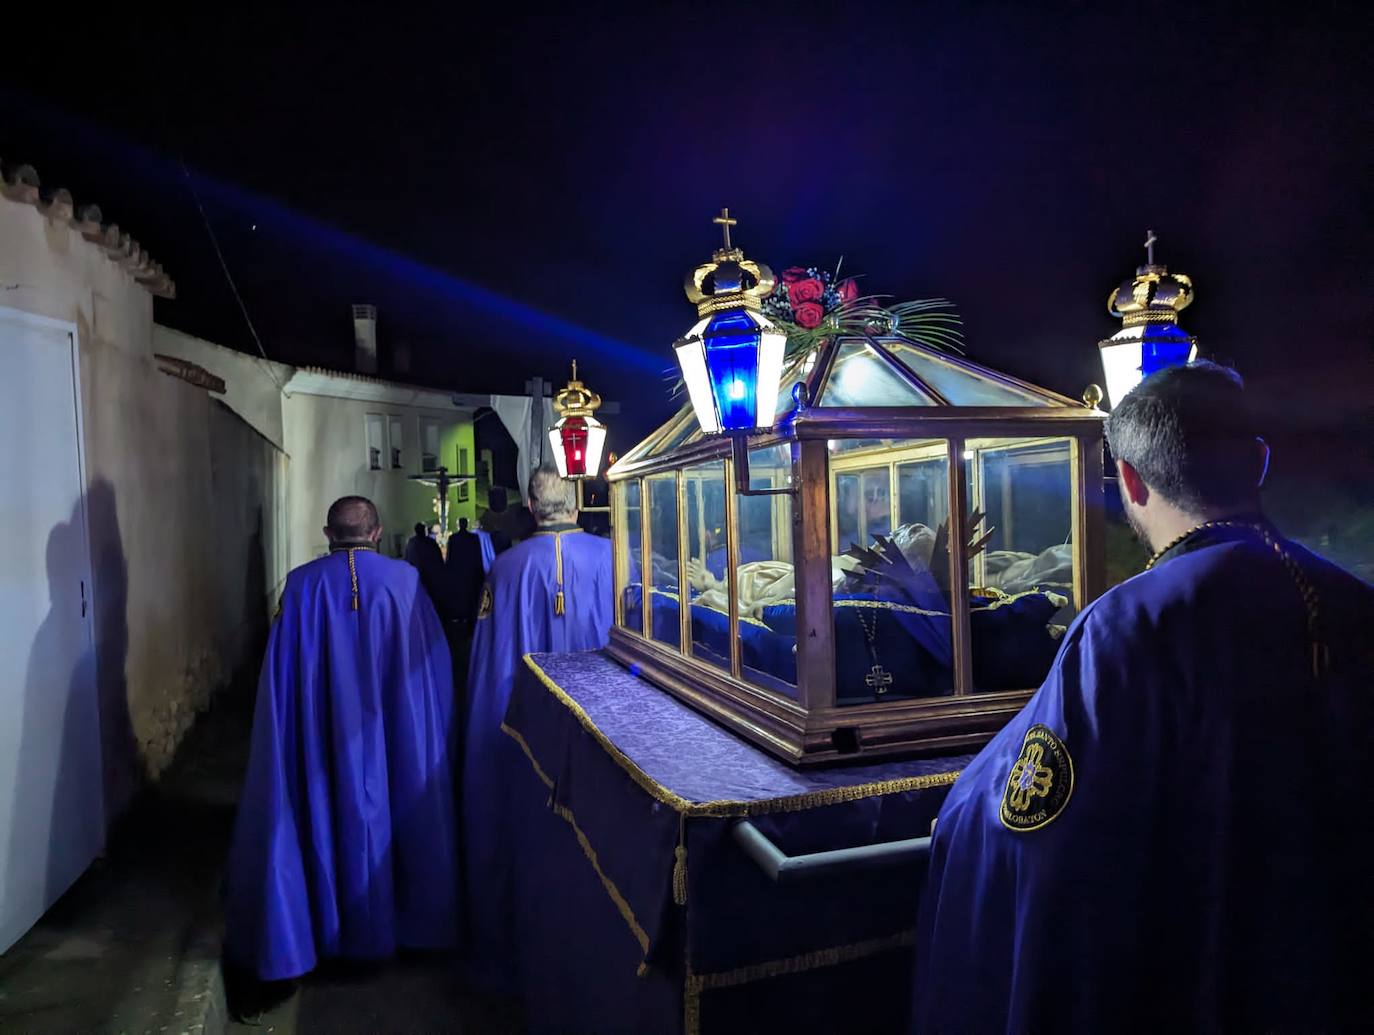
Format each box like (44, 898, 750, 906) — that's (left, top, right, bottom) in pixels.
(915, 364, 1374, 1032)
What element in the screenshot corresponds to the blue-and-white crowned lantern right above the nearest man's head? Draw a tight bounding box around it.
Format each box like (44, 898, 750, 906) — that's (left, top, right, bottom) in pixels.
(1098, 230, 1198, 405)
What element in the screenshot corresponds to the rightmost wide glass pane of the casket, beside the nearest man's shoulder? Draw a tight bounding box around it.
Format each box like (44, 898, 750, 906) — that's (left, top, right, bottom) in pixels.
(965, 438, 1077, 690)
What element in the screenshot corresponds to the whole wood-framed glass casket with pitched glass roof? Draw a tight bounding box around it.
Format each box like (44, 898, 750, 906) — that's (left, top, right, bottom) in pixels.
(607, 337, 1103, 764)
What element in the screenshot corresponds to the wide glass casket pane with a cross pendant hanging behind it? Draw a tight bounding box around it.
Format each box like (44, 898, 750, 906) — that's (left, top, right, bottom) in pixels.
(830, 440, 954, 705)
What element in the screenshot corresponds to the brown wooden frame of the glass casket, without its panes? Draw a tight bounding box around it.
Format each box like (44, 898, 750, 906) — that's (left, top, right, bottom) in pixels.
(607, 338, 1105, 766)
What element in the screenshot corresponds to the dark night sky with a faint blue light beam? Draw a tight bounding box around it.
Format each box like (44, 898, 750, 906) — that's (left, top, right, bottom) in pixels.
(0, 3, 1374, 458)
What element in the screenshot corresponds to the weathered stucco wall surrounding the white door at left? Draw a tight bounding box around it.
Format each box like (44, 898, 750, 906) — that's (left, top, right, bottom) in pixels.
(0, 198, 284, 819)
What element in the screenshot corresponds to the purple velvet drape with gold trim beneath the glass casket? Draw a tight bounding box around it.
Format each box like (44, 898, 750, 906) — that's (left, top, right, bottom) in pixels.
(502, 653, 967, 1031)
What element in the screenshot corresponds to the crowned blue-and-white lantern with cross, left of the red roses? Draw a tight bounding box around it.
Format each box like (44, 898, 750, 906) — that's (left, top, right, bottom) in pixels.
(673, 209, 787, 436)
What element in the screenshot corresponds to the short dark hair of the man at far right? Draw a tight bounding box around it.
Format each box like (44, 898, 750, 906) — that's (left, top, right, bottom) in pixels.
(1106, 360, 1260, 511)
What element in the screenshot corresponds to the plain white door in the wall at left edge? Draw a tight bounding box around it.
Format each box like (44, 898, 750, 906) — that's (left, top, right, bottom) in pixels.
(0, 308, 104, 953)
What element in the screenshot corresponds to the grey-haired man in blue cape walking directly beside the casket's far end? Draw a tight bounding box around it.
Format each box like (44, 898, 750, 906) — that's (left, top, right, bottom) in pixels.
(463, 467, 614, 988)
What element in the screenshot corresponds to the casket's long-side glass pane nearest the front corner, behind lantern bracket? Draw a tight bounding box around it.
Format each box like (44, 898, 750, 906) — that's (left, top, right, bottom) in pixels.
(735, 445, 797, 698)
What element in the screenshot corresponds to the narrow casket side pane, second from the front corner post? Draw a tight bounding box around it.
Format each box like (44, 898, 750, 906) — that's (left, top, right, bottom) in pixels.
(683, 460, 730, 672)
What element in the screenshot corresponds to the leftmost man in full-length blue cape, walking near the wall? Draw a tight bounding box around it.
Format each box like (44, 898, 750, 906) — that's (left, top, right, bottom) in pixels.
(225, 496, 459, 981)
